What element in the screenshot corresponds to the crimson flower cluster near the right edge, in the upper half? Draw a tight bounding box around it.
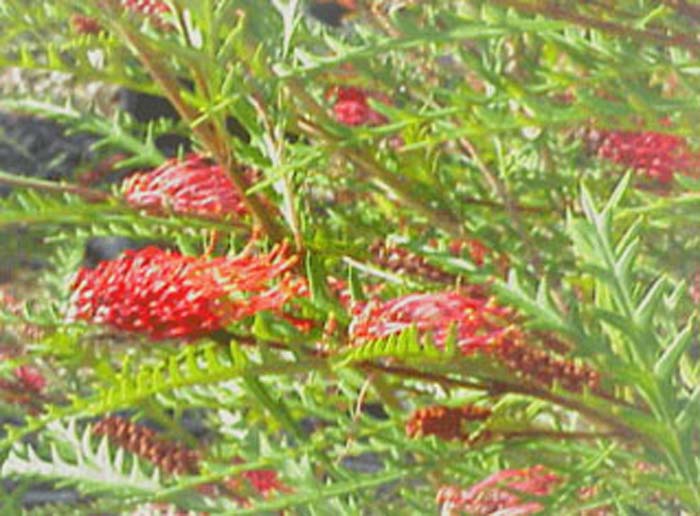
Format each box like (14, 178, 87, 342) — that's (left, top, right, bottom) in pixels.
(598, 131, 693, 184)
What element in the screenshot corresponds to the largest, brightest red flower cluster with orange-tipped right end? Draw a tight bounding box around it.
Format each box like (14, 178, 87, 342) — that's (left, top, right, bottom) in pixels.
(69, 245, 306, 340)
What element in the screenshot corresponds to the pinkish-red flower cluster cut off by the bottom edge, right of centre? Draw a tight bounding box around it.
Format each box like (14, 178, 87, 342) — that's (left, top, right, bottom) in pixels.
(437, 465, 561, 516)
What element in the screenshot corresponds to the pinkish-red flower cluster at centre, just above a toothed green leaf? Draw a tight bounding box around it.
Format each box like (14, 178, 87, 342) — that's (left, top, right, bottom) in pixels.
(350, 292, 510, 354)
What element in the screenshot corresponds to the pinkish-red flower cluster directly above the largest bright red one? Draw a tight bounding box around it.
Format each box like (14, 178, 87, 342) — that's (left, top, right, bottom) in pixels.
(122, 154, 252, 217)
